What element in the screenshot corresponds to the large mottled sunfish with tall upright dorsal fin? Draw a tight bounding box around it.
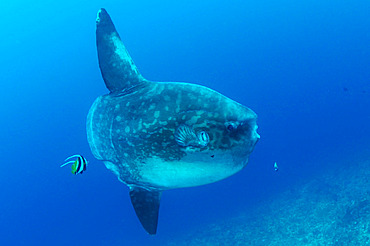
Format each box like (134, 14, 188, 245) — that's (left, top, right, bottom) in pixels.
(87, 9, 260, 234)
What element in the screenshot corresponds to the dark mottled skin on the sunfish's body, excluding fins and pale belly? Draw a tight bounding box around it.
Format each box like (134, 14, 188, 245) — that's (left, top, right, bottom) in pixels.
(88, 81, 258, 189)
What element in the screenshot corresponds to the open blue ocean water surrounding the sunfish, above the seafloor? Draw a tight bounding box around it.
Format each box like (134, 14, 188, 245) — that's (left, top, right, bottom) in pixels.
(0, 0, 370, 245)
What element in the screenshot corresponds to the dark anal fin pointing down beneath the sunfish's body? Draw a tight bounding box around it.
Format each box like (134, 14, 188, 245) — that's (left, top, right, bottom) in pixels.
(130, 187, 162, 235)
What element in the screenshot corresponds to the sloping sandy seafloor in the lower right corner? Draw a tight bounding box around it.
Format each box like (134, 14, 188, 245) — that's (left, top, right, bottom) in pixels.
(168, 152, 370, 246)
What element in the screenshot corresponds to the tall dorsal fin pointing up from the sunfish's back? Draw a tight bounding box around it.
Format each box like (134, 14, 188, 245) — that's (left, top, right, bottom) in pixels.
(96, 9, 145, 92)
